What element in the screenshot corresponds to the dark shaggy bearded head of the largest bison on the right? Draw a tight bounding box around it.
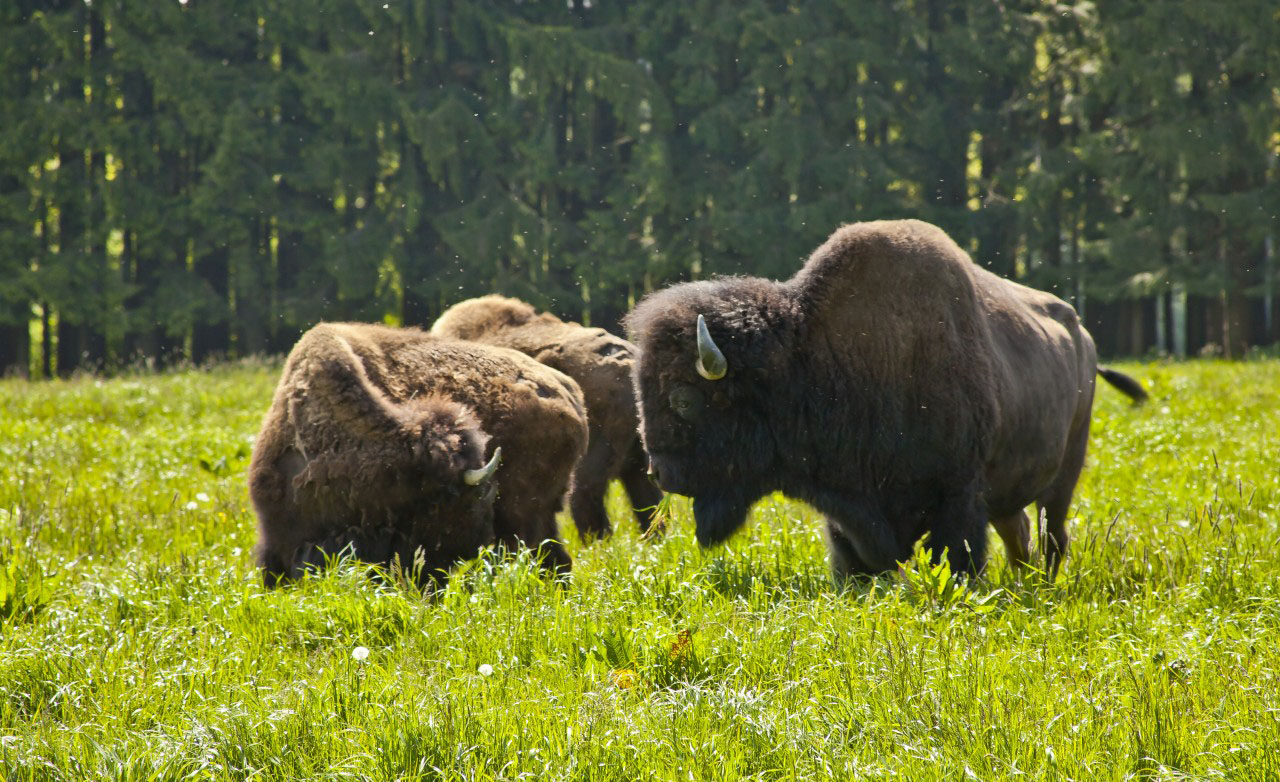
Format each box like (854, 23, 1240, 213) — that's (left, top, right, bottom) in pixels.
(626, 279, 791, 545)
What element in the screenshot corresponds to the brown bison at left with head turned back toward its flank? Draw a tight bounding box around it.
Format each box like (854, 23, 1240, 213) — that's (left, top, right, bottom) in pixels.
(248, 324, 586, 586)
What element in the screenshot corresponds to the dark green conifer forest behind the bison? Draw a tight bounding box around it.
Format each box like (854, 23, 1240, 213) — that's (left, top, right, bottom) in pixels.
(0, 0, 1280, 376)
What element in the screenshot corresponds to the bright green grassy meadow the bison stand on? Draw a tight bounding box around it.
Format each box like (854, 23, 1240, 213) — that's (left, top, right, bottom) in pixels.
(0, 360, 1280, 781)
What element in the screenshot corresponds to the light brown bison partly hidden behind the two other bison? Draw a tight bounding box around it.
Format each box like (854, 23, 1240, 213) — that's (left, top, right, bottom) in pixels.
(431, 296, 662, 538)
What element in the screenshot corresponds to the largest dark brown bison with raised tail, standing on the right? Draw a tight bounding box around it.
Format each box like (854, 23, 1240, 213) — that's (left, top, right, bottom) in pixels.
(627, 220, 1146, 579)
